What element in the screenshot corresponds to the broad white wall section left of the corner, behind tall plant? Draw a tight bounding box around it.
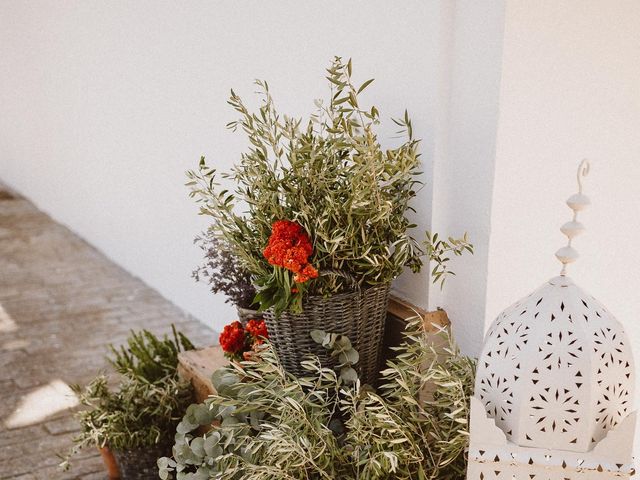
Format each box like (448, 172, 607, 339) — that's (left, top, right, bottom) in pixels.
(0, 0, 449, 334)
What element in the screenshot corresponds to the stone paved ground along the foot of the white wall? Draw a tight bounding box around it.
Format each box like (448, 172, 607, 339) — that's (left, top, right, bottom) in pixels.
(0, 184, 214, 480)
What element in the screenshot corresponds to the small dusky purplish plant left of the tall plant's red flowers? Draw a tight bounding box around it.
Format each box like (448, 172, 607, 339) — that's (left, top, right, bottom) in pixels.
(192, 229, 262, 324)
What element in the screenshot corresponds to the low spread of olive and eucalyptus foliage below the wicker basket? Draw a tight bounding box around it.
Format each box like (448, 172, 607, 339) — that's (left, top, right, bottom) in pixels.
(158, 320, 475, 480)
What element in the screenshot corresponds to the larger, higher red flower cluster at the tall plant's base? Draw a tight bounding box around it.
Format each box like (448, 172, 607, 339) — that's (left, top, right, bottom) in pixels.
(263, 220, 318, 283)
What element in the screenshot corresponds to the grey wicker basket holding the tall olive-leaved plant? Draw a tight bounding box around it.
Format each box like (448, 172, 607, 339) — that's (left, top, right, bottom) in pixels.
(264, 278, 390, 385)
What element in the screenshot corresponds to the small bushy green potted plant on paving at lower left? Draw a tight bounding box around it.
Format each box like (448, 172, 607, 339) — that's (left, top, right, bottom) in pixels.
(62, 327, 193, 480)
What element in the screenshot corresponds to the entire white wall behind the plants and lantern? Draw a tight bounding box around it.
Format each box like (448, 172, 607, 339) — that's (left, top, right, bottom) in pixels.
(0, 0, 640, 366)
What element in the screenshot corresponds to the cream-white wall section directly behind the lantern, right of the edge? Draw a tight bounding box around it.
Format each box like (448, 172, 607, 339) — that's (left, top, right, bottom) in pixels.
(486, 0, 640, 457)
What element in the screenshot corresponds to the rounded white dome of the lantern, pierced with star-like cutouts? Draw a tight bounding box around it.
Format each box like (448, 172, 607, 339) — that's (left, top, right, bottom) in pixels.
(476, 276, 634, 452)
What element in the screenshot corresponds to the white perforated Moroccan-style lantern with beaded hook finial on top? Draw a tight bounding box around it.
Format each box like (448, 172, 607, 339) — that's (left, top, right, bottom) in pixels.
(467, 161, 635, 480)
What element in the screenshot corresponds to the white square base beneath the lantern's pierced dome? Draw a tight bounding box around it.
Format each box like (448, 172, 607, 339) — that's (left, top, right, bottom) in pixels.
(467, 396, 636, 480)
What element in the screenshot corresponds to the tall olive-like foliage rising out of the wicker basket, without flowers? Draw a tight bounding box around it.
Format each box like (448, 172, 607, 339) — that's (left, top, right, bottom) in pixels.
(187, 57, 470, 312)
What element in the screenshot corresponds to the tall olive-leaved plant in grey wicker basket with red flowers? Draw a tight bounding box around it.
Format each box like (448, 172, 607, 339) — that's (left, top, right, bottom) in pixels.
(187, 57, 471, 383)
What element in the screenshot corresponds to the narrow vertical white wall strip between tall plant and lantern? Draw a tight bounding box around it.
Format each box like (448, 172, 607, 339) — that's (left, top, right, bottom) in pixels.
(429, 0, 504, 355)
